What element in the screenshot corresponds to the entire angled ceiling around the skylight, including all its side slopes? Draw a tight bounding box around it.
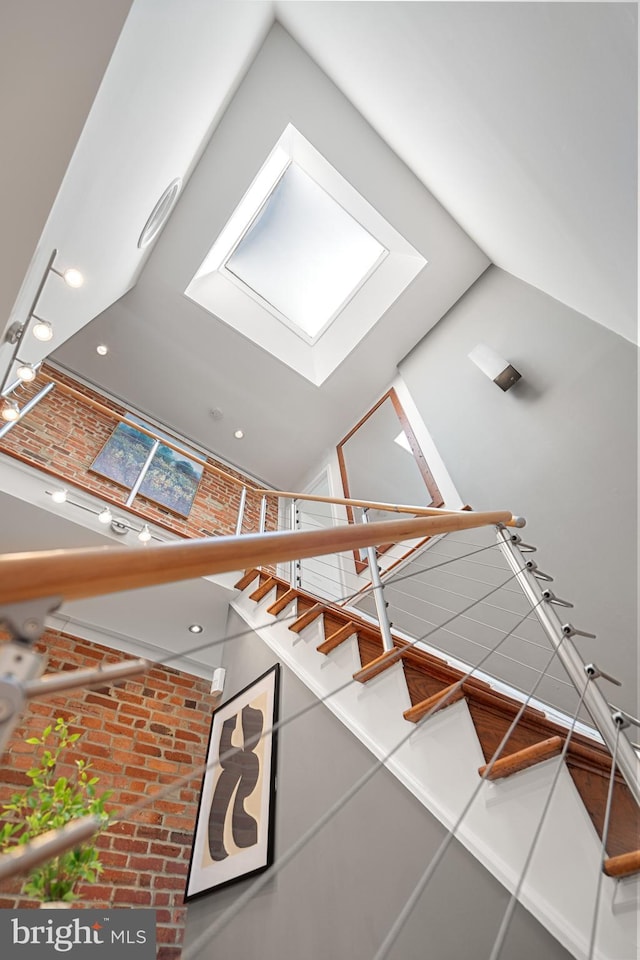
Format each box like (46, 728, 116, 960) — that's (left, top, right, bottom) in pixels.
(0, 0, 637, 688)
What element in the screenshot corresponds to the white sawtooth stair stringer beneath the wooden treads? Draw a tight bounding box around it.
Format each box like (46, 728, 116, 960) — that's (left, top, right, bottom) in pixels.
(231, 593, 639, 960)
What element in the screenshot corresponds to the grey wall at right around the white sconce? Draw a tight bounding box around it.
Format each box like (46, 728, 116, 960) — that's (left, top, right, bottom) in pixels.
(399, 267, 638, 715)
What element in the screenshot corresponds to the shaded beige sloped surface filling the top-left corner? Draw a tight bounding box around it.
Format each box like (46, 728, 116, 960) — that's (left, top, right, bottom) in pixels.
(0, 0, 132, 350)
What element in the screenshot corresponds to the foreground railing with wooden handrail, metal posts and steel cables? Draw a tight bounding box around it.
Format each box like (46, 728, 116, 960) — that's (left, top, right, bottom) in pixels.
(0, 492, 640, 960)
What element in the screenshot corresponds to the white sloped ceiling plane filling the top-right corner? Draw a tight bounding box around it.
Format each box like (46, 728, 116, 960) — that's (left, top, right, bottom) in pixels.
(275, 2, 637, 341)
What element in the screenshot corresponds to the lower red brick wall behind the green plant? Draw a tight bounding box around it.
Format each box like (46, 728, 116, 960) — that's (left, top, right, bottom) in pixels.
(0, 630, 212, 960)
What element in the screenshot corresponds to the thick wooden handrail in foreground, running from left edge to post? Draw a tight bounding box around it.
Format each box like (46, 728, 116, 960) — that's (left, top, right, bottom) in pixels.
(0, 510, 512, 605)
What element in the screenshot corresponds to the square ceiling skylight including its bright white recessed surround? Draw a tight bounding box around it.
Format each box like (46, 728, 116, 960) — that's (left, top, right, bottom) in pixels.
(185, 124, 426, 387)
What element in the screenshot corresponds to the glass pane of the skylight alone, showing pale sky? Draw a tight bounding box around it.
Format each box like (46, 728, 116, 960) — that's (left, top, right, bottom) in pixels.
(225, 162, 387, 340)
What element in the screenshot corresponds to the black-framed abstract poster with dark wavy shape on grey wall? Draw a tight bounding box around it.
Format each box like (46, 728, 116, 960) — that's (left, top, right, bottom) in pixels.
(184, 664, 280, 902)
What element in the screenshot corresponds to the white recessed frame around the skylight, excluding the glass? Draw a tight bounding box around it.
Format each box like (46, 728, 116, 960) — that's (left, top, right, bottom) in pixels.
(184, 123, 428, 387)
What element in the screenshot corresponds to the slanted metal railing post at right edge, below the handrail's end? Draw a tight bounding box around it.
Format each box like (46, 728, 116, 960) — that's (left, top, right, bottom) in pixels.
(498, 527, 640, 805)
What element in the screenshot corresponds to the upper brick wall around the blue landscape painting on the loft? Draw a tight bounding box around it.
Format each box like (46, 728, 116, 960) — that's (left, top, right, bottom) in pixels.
(0, 367, 277, 537)
